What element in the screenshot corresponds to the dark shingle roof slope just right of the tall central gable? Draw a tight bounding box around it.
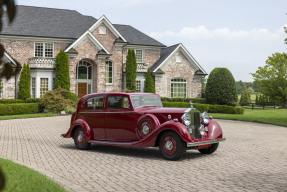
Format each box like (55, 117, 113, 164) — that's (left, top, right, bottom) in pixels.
(114, 24, 166, 47)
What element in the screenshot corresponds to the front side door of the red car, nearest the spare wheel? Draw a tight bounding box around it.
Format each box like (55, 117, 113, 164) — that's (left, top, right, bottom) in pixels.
(105, 95, 137, 141)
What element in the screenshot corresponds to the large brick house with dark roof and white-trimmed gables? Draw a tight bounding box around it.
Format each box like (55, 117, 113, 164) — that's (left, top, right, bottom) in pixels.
(0, 5, 206, 99)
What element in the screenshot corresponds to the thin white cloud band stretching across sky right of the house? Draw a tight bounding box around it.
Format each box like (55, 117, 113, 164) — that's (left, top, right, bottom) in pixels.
(150, 24, 287, 41)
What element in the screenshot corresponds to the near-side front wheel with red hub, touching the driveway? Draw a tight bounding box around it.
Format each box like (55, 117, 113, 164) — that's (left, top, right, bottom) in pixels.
(159, 131, 186, 161)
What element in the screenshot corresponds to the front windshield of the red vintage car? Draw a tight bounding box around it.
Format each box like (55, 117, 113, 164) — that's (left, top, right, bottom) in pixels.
(131, 95, 162, 108)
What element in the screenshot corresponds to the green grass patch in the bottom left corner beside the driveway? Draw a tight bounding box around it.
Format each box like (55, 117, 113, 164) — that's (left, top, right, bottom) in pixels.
(0, 158, 66, 192)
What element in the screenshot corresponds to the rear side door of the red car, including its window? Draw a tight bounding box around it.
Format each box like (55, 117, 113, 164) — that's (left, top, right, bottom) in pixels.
(85, 95, 106, 140)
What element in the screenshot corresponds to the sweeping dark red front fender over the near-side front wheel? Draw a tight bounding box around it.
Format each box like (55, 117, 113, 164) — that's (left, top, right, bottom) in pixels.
(133, 121, 193, 147)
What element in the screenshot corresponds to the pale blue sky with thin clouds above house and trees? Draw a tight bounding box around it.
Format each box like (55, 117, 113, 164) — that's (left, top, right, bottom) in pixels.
(16, 0, 287, 82)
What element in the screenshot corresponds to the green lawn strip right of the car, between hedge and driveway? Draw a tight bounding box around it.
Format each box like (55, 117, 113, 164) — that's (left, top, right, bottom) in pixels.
(210, 108, 287, 127)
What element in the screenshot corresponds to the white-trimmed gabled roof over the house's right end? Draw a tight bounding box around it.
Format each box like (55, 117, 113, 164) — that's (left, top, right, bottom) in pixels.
(150, 43, 207, 75)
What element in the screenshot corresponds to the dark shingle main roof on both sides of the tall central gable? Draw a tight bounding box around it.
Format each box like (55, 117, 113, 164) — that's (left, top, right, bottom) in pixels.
(0, 5, 165, 47)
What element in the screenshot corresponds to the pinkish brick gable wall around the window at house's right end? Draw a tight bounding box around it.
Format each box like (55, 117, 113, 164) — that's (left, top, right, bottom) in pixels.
(155, 51, 202, 98)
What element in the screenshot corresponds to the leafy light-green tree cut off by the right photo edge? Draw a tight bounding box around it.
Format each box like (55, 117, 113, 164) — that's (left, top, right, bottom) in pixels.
(251, 53, 287, 107)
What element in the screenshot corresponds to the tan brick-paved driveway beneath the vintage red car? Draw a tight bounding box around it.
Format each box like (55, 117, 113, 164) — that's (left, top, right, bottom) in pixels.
(0, 116, 287, 192)
